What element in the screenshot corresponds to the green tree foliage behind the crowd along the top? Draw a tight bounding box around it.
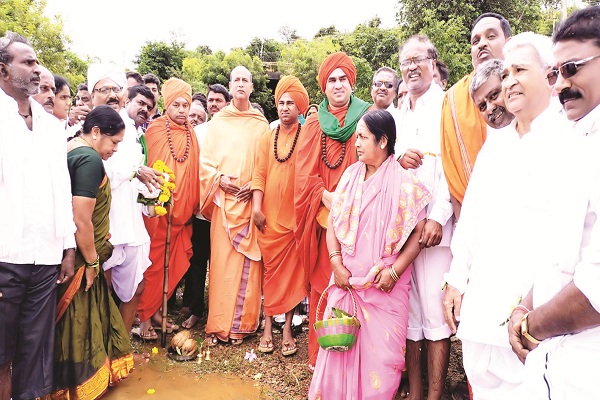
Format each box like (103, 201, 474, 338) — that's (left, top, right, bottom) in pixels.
(0, 0, 580, 120)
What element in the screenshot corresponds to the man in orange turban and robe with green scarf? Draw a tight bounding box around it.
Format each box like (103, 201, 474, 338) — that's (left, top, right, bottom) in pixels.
(294, 52, 369, 370)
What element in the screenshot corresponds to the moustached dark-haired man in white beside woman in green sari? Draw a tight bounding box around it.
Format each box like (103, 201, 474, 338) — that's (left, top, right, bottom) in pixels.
(102, 85, 159, 339)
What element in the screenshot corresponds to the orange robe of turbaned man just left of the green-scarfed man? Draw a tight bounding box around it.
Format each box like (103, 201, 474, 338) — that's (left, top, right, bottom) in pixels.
(252, 124, 308, 316)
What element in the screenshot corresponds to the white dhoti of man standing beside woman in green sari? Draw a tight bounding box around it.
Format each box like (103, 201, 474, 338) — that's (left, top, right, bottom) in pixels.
(102, 242, 151, 303)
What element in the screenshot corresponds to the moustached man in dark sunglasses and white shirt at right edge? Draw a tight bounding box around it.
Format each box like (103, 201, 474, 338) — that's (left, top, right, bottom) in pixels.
(509, 6, 600, 400)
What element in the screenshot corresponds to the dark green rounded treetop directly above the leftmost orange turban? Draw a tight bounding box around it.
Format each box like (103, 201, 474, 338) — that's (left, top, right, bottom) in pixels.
(135, 40, 186, 82)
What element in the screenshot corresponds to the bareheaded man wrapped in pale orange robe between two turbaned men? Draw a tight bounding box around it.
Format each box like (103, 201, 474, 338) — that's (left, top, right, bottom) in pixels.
(200, 66, 269, 346)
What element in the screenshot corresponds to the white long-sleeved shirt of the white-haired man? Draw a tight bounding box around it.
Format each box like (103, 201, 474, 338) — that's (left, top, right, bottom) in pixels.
(445, 107, 572, 348)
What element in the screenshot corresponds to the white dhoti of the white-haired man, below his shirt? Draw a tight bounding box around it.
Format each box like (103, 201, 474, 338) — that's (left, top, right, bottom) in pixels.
(462, 333, 525, 400)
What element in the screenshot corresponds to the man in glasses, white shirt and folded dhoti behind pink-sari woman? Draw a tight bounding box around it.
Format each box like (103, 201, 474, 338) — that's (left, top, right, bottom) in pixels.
(395, 36, 454, 399)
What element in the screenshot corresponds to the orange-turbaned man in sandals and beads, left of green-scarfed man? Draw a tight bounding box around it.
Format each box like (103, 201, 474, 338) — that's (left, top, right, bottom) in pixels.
(252, 76, 308, 356)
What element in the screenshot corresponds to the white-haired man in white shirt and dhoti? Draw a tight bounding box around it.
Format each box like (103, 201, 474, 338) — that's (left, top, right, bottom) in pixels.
(444, 32, 573, 399)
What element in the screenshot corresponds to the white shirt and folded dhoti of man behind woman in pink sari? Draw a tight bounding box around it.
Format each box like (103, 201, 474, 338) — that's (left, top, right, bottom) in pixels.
(392, 83, 454, 341)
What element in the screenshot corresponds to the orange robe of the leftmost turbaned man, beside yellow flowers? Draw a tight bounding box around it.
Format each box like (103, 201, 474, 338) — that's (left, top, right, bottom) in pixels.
(138, 115, 200, 321)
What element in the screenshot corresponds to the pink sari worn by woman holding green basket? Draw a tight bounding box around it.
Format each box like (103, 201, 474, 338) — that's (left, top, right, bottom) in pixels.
(309, 156, 431, 400)
